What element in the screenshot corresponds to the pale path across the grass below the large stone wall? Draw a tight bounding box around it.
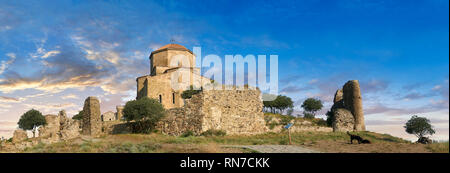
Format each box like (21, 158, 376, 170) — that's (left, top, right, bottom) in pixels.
(227, 145, 320, 153)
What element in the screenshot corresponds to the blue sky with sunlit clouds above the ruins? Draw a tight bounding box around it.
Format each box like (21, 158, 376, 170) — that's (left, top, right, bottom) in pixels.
(0, 0, 449, 139)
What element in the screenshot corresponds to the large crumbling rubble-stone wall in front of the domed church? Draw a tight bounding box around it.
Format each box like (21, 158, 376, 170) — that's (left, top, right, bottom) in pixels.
(157, 89, 268, 135)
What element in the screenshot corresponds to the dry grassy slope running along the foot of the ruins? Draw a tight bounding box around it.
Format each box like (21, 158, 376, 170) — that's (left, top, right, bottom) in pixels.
(24, 132, 448, 153)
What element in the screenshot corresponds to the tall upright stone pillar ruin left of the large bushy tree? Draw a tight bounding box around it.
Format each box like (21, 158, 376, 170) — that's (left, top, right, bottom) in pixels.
(82, 97, 102, 136)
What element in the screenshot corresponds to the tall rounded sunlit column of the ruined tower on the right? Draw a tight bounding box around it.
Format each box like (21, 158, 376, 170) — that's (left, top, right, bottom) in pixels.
(343, 80, 366, 131)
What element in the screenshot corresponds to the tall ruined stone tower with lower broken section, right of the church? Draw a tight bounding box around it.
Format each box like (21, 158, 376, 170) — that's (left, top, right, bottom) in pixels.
(331, 80, 366, 131)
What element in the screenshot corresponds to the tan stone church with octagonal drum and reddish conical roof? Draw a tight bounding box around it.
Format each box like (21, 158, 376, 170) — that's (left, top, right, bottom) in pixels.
(136, 44, 211, 109)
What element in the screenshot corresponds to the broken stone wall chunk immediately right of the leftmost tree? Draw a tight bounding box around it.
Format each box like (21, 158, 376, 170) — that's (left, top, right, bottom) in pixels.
(39, 115, 61, 141)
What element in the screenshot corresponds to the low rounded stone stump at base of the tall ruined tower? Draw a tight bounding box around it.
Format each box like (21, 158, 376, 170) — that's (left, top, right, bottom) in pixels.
(333, 108, 355, 132)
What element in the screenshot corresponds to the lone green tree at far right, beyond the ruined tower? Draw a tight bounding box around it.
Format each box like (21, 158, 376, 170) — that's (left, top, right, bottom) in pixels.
(403, 115, 435, 139)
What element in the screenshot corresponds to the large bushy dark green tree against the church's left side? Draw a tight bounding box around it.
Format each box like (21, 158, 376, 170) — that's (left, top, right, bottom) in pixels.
(123, 97, 165, 133)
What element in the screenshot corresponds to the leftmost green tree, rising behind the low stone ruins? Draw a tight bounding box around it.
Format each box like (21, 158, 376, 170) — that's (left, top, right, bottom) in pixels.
(17, 109, 47, 138)
